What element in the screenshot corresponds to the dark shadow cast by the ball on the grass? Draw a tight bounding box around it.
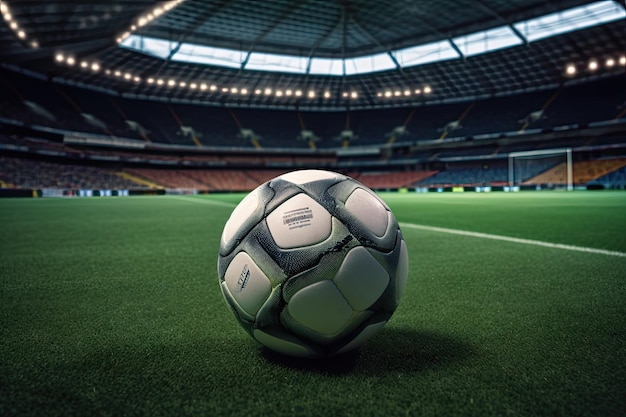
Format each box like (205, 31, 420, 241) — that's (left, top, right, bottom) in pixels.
(261, 328, 476, 375)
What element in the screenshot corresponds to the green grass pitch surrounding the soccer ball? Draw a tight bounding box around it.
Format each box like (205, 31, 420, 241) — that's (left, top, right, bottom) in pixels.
(0, 192, 626, 417)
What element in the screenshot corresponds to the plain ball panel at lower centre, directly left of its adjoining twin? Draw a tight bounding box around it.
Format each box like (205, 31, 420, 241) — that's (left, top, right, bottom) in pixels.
(287, 281, 353, 335)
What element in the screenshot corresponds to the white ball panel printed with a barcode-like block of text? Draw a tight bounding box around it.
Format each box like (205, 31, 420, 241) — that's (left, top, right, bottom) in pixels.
(267, 194, 332, 249)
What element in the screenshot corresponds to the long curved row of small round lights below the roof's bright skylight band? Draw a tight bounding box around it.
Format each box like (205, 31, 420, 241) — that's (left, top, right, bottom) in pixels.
(55, 52, 432, 99)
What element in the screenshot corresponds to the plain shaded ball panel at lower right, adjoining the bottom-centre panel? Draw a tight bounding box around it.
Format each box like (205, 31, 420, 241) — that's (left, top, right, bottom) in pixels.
(333, 246, 389, 311)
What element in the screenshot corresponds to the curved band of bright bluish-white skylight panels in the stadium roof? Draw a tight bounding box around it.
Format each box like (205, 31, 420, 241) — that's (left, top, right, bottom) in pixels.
(118, 0, 626, 78)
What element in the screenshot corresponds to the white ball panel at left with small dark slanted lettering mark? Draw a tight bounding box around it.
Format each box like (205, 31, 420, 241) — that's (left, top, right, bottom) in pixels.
(224, 252, 272, 316)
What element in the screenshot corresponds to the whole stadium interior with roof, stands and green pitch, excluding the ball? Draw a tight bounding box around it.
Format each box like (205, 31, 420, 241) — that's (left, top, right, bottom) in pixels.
(0, 0, 626, 416)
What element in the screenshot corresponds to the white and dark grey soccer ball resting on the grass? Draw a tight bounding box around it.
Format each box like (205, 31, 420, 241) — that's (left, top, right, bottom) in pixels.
(217, 170, 409, 358)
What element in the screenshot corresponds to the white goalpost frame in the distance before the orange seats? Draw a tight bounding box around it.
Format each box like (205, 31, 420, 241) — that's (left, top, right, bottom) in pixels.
(508, 148, 574, 191)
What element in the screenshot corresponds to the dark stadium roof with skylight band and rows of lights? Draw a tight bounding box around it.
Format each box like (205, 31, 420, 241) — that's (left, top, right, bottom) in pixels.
(0, 0, 626, 110)
